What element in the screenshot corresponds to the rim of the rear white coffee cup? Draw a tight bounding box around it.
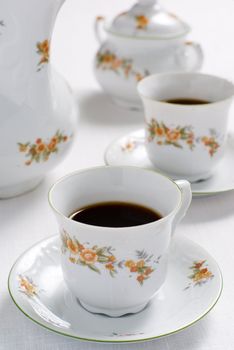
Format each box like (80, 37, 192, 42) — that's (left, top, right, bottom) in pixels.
(137, 72, 234, 108)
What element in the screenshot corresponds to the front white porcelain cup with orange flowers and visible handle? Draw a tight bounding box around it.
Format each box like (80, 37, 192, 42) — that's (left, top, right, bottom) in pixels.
(49, 167, 191, 317)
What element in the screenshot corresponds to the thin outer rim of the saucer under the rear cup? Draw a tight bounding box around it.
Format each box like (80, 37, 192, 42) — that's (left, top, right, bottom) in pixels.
(103, 128, 234, 197)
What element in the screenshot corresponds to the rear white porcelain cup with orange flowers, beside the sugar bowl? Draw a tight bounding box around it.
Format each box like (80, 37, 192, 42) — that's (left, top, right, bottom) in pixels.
(138, 73, 234, 182)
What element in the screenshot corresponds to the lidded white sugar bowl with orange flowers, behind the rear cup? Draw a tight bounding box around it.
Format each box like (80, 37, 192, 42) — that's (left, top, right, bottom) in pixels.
(94, 0, 203, 109)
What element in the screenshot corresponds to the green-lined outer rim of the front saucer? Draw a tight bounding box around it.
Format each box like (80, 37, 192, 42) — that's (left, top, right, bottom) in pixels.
(7, 234, 223, 344)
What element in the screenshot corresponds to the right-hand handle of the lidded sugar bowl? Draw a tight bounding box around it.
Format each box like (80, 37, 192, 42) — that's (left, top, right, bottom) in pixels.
(176, 41, 204, 72)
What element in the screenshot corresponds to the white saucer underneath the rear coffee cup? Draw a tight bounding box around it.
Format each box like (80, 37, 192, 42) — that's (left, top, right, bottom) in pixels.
(105, 129, 234, 196)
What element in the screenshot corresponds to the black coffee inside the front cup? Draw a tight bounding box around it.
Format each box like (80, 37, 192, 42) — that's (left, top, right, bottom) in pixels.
(70, 202, 162, 227)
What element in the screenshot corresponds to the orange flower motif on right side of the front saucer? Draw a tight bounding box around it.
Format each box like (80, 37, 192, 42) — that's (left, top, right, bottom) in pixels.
(185, 260, 214, 289)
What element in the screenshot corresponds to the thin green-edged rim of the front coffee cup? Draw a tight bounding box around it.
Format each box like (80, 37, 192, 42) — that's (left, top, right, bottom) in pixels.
(48, 165, 182, 232)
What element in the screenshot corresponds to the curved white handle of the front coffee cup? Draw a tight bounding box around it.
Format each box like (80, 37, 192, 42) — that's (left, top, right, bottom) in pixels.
(172, 180, 192, 234)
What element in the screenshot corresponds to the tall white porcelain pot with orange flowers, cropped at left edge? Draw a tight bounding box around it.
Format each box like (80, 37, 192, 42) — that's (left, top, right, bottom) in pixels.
(0, 0, 77, 198)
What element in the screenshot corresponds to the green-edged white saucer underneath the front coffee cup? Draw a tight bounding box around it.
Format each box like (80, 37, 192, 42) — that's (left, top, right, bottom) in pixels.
(8, 235, 222, 343)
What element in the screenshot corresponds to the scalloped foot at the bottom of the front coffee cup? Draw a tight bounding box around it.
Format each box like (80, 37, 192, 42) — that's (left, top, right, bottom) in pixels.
(79, 299, 148, 317)
